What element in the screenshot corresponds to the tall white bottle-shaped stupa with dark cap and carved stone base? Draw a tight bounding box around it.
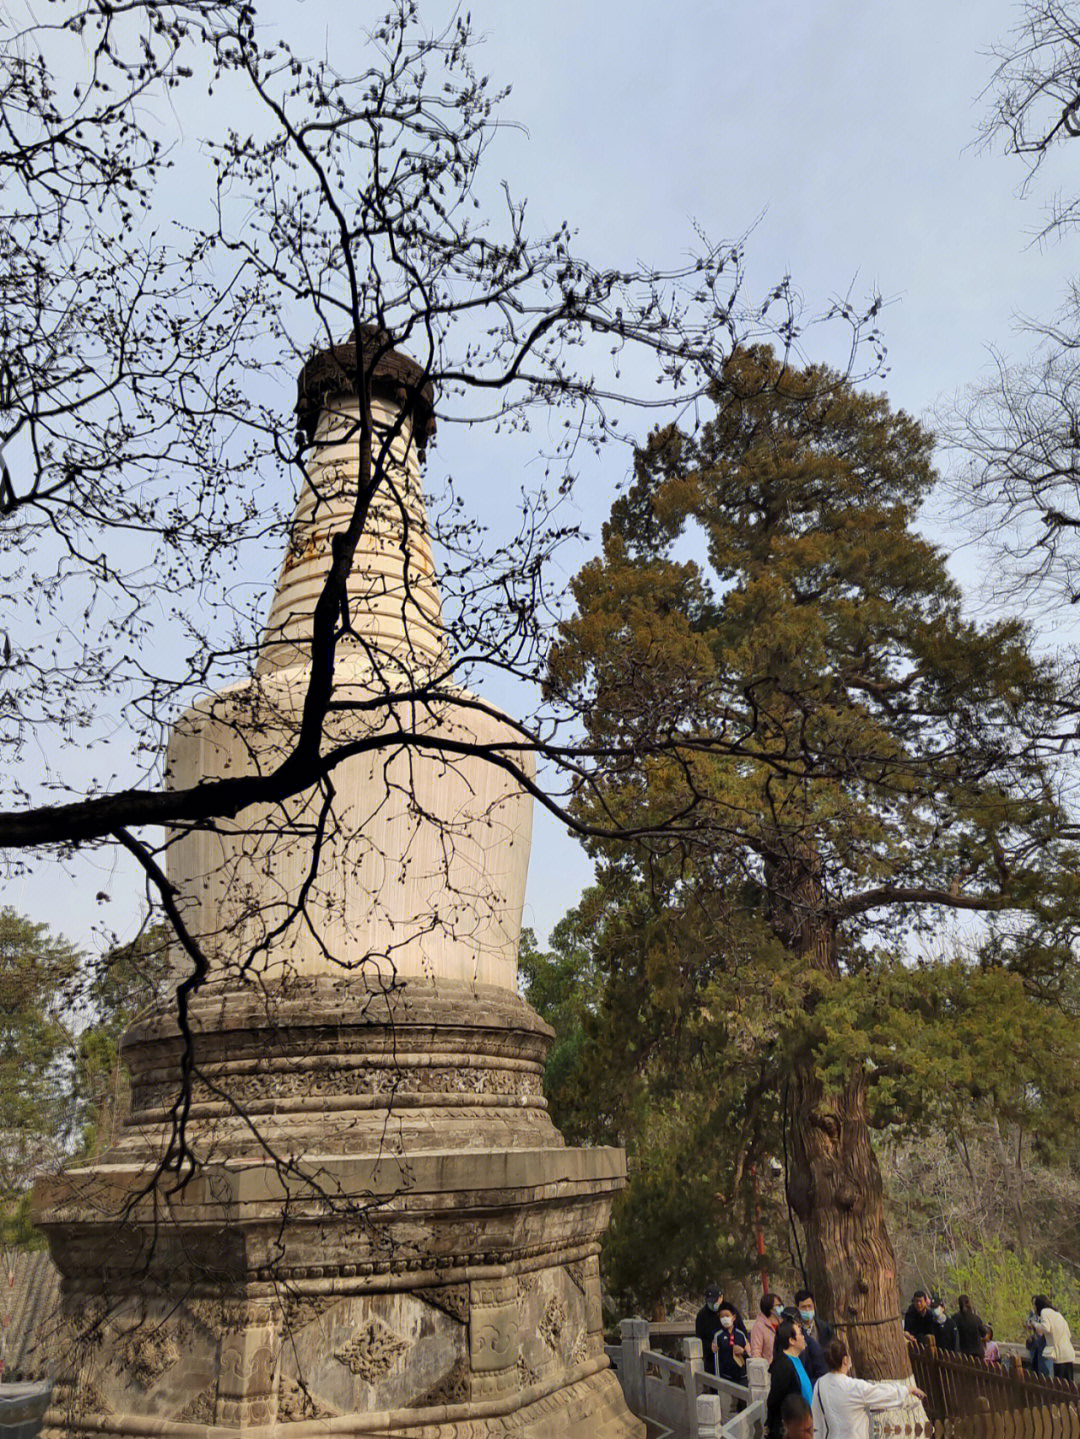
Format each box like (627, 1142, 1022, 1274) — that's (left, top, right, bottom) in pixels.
(37, 337, 641, 1439)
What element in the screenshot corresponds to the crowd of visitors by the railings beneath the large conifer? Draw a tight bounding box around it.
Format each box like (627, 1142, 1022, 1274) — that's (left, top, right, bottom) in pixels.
(695, 1285, 1076, 1439)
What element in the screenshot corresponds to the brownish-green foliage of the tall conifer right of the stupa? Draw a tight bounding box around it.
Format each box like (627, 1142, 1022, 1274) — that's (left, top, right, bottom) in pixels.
(548, 348, 1080, 1304)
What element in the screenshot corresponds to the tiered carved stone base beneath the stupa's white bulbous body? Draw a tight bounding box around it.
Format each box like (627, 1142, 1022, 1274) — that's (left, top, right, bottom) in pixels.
(37, 979, 643, 1439)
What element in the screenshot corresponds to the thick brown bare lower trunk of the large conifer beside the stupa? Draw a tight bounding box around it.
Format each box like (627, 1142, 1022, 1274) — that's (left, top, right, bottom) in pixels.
(788, 1056, 912, 1379)
